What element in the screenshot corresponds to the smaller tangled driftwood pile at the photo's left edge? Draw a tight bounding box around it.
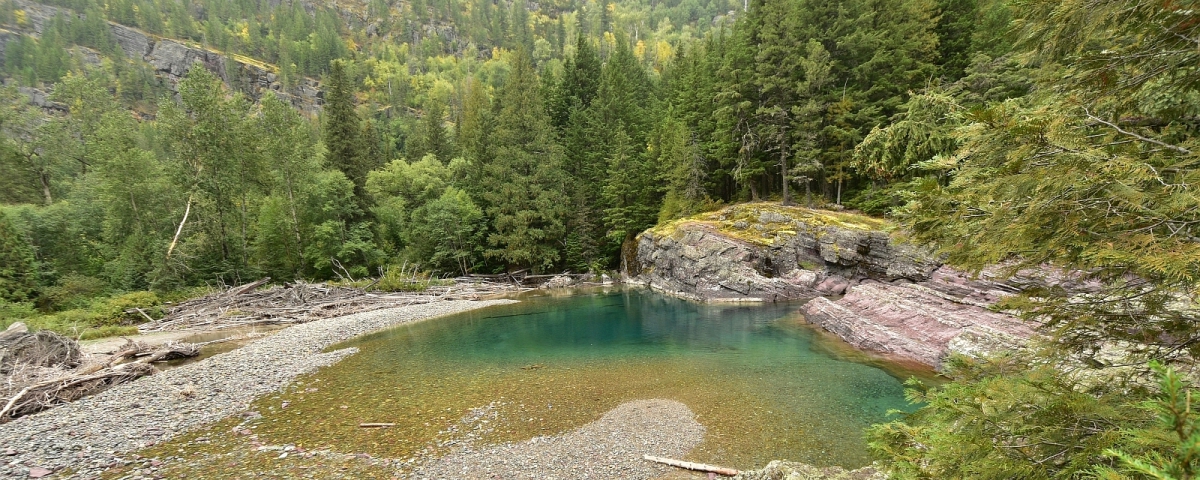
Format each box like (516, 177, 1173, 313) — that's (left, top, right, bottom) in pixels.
(0, 323, 200, 422)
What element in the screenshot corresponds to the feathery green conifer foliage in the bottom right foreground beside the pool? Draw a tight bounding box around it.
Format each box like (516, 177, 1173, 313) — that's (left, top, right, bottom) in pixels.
(868, 355, 1148, 480)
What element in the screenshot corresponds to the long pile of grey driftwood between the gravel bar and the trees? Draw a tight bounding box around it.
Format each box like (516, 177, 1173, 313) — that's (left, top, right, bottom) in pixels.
(138, 277, 540, 332)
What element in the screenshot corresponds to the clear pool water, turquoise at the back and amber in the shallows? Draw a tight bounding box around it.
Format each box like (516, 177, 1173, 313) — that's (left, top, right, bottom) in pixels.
(250, 290, 926, 468)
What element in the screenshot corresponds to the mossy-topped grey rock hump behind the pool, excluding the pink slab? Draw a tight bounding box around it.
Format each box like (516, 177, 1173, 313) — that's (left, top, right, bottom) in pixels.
(635, 203, 941, 301)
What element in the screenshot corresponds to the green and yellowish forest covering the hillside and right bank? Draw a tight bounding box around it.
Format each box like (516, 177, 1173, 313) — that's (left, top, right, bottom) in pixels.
(0, 0, 1200, 472)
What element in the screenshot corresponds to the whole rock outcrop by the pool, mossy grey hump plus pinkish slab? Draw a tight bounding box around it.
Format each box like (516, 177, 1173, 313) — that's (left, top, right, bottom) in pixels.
(634, 203, 1054, 367)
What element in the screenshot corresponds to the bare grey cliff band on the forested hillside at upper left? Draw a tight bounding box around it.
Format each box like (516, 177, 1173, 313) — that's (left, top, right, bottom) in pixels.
(0, 0, 324, 113)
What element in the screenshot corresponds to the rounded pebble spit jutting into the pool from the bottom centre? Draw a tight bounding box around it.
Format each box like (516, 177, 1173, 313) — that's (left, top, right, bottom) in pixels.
(410, 400, 704, 480)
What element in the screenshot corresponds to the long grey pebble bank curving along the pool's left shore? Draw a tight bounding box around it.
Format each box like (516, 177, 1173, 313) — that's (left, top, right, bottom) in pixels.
(0, 300, 514, 479)
